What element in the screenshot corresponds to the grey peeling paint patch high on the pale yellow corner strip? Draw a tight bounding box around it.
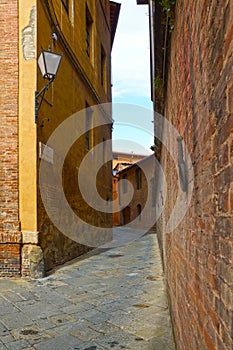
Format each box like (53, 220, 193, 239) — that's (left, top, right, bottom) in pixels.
(22, 6, 36, 60)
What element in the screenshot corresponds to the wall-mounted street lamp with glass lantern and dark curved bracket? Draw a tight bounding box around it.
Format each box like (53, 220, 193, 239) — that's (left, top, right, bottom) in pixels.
(35, 50, 62, 123)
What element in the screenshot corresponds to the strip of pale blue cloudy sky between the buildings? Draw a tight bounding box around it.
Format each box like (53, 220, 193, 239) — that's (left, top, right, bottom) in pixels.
(112, 0, 154, 154)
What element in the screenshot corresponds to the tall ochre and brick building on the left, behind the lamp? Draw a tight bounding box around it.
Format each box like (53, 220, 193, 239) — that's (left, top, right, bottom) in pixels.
(0, 0, 120, 277)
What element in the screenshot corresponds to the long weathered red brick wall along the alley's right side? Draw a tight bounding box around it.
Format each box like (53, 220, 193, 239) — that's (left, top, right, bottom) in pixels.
(159, 0, 233, 350)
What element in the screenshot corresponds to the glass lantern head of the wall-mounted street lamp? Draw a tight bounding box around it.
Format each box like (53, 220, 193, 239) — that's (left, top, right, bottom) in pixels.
(38, 50, 62, 80)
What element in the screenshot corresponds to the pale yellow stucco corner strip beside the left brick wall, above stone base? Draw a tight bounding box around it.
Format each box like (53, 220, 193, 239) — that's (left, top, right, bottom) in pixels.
(19, 0, 37, 232)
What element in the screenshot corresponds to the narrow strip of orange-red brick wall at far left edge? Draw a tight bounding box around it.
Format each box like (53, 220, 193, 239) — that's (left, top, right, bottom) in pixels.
(0, 0, 21, 276)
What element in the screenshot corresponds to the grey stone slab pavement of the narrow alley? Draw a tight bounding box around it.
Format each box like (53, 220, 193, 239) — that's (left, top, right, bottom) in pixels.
(0, 230, 175, 350)
